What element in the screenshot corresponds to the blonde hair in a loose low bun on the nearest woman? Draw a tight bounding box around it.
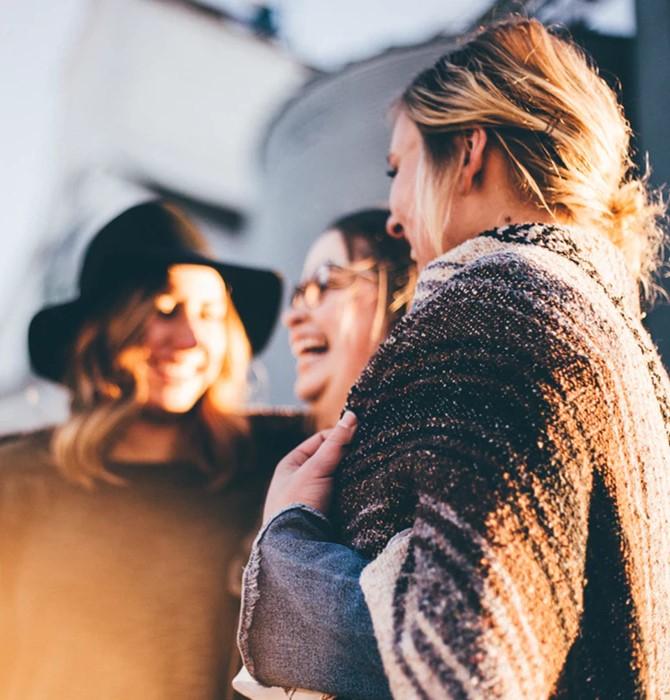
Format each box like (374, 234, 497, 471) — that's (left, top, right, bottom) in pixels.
(398, 17, 665, 294)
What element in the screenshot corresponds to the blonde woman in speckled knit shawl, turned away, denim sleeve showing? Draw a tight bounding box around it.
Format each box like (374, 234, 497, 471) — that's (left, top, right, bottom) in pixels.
(240, 19, 670, 700)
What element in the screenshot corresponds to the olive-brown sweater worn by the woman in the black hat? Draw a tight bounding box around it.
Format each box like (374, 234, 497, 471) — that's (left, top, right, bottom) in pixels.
(0, 416, 303, 700)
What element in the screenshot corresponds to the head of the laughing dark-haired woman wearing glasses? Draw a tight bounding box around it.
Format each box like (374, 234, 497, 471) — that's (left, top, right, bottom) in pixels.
(283, 209, 415, 430)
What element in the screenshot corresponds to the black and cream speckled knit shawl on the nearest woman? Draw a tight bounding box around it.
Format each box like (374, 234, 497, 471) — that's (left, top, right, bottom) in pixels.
(335, 224, 670, 700)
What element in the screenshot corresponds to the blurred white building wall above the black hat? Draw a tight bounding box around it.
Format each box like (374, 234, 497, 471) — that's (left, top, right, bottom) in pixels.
(55, 0, 306, 216)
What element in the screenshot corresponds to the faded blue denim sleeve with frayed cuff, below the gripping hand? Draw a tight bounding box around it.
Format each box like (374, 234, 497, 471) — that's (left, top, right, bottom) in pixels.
(239, 506, 391, 700)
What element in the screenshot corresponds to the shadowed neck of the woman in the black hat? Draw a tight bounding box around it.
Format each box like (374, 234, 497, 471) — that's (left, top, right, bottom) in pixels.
(110, 415, 184, 462)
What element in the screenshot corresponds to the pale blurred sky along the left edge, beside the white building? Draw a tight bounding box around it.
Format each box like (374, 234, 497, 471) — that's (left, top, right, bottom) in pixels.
(0, 0, 90, 432)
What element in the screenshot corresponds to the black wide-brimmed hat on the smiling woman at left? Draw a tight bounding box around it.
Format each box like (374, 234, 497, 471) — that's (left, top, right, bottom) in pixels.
(28, 201, 282, 382)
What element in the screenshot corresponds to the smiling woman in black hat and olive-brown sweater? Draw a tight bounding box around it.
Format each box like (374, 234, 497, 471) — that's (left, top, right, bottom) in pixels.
(0, 202, 302, 700)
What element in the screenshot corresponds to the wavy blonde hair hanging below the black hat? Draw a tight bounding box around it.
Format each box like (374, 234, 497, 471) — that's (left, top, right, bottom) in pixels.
(52, 278, 251, 488)
